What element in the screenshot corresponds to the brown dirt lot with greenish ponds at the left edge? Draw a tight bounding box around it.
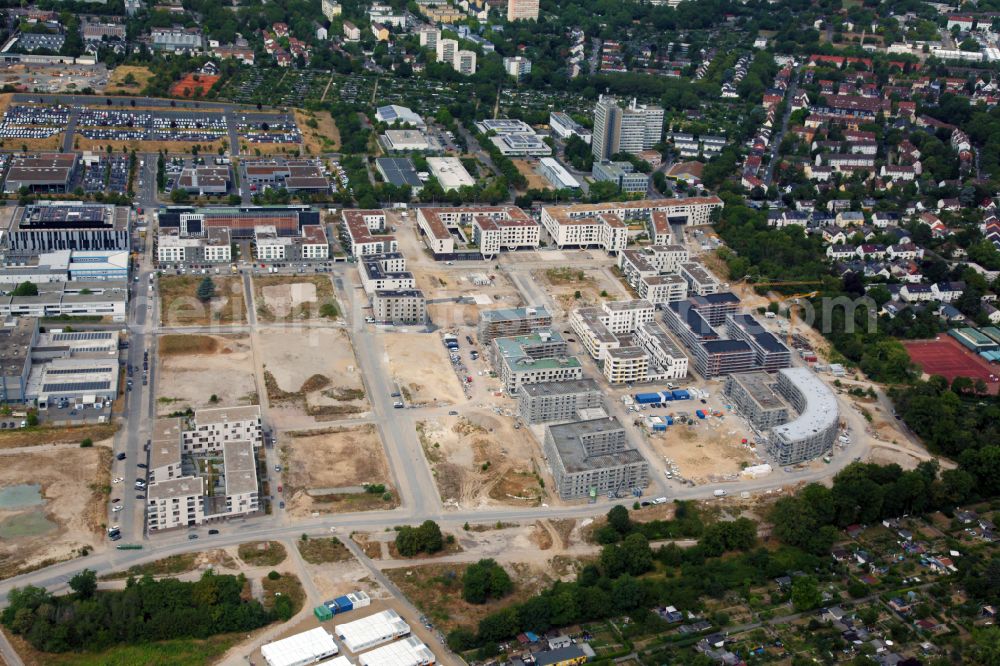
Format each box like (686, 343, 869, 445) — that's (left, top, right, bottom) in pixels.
(0, 446, 111, 578)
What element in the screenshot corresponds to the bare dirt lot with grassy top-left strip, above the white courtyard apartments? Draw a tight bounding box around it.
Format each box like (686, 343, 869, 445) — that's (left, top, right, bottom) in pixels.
(156, 335, 257, 414)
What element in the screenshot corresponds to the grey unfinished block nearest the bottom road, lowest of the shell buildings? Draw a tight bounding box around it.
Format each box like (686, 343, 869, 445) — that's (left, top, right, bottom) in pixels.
(543, 417, 649, 500)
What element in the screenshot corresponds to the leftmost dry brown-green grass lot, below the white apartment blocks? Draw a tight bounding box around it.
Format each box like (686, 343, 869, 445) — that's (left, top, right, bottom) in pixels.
(159, 275, 246, 326)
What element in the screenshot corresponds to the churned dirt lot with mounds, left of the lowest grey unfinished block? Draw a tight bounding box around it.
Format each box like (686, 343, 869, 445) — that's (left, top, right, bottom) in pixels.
(417, 410, 552, 508)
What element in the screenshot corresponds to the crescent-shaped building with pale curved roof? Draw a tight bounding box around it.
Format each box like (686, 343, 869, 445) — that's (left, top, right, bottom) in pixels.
(767, 368, 840, 465)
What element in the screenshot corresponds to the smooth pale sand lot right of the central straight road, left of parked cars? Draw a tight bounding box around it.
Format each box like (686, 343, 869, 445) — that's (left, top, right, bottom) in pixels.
(382, 333, 464, 405)
